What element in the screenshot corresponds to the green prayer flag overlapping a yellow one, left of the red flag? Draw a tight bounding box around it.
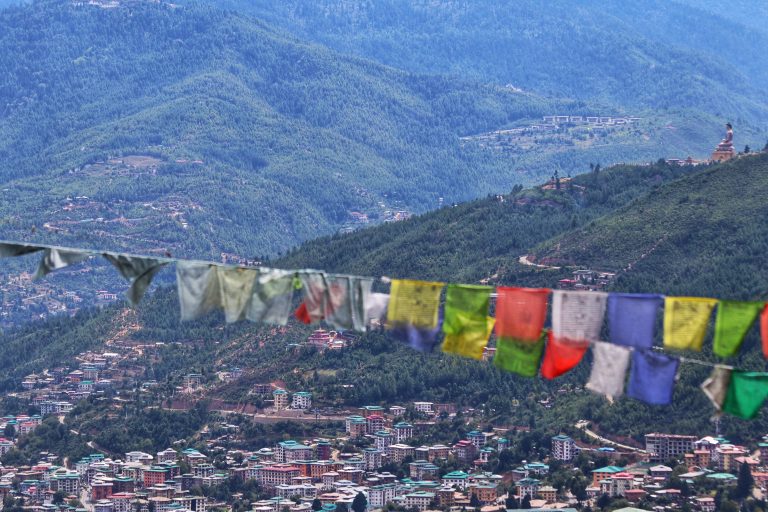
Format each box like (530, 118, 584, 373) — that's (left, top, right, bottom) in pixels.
(443, 284, 496, 359)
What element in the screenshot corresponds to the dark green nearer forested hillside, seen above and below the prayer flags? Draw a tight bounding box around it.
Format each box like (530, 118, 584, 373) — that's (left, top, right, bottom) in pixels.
(2, 155, 768, 447)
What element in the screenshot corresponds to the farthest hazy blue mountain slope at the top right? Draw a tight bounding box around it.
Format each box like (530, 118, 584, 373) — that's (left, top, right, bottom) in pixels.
(217, 0, 768, 122)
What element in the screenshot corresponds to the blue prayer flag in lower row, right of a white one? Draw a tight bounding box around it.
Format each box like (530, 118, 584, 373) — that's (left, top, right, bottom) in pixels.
(627, 350, 680, 405)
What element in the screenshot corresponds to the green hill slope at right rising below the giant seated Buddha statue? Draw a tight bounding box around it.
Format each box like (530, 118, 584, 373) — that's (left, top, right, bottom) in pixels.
(534, 154, 768, 299)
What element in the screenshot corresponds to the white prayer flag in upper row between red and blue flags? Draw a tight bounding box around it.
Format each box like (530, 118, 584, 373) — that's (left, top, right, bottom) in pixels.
(552, 290, 608, 344)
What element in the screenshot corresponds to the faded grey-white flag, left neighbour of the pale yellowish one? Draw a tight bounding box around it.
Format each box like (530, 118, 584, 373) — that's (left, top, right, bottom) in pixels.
(176, 261, 221, 321)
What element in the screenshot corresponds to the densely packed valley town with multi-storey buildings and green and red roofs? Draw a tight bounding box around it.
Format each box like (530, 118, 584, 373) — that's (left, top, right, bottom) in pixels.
(0, 329, 768, 512)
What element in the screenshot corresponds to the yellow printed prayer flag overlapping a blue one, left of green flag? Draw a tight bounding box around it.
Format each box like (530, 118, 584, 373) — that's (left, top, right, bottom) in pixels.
(387, 279, 444, 329)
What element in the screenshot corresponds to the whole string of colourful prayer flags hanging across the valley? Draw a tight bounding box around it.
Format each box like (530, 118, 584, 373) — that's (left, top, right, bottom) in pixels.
(0, 241, 768, 419)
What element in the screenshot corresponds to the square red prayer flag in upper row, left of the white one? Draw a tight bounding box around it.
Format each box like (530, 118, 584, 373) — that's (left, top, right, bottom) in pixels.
(496, 287, 550, 344)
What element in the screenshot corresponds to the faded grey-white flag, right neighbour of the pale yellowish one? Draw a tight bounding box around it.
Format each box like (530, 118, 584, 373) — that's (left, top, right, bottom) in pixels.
(245, 268, 296, 325)
